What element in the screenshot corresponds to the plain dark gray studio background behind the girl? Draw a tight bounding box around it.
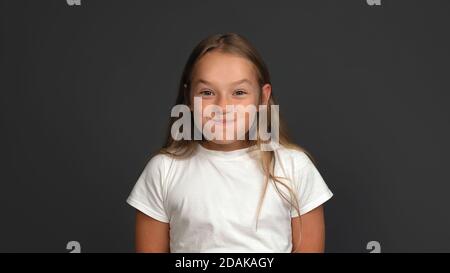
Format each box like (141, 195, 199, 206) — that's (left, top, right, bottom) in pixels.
(0, 0, 450, 252)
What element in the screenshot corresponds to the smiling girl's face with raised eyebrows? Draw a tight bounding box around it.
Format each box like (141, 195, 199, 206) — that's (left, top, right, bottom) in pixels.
(191, 51, 271, 148)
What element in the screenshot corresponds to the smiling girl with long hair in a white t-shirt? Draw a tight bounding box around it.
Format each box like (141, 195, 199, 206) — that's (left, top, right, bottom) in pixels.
(127, 33, 333, 252)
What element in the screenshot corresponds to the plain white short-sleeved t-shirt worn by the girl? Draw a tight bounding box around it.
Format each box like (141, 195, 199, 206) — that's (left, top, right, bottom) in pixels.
(127, 145, 333, 253)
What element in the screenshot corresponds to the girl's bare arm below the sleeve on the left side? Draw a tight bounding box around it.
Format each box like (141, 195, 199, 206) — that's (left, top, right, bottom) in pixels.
(135, 210, 170, 253)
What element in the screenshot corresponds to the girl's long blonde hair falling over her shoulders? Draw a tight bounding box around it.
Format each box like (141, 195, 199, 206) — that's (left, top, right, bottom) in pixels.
(158, 33, 315, 250)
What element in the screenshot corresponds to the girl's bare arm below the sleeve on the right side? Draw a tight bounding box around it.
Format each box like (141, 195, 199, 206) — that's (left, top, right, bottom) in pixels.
(291, 205, 325, 253)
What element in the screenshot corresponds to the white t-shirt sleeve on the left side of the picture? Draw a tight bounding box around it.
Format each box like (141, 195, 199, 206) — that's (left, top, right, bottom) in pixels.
(127, 155, 169, 223)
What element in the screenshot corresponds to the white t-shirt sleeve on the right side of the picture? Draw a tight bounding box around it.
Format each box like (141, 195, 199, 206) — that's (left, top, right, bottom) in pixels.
(291, 154, 333, 217)
